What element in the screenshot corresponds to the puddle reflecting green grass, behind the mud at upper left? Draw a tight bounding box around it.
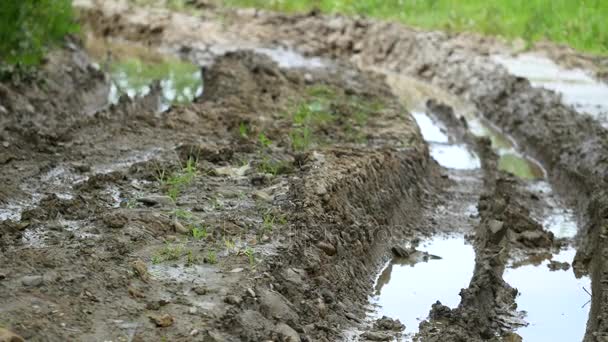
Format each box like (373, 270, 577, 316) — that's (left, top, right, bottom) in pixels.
(86, 35, 203, 112)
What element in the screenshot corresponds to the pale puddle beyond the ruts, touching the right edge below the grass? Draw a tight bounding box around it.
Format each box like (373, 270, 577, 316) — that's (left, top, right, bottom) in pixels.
(493, 54, 608, 127)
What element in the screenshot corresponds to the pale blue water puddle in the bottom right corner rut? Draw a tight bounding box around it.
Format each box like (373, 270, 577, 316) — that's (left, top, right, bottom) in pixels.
(504, 248, 591, 341)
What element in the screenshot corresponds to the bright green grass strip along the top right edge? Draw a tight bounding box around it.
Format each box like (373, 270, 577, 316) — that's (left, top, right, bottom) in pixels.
(226, 0, 608, 54)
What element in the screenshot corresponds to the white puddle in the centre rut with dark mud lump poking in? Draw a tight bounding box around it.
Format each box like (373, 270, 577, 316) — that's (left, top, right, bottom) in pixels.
(372, 237, 475, 333)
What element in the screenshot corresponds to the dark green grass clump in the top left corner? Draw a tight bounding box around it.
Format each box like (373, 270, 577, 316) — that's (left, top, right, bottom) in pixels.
(0, 0, 79, 66)
